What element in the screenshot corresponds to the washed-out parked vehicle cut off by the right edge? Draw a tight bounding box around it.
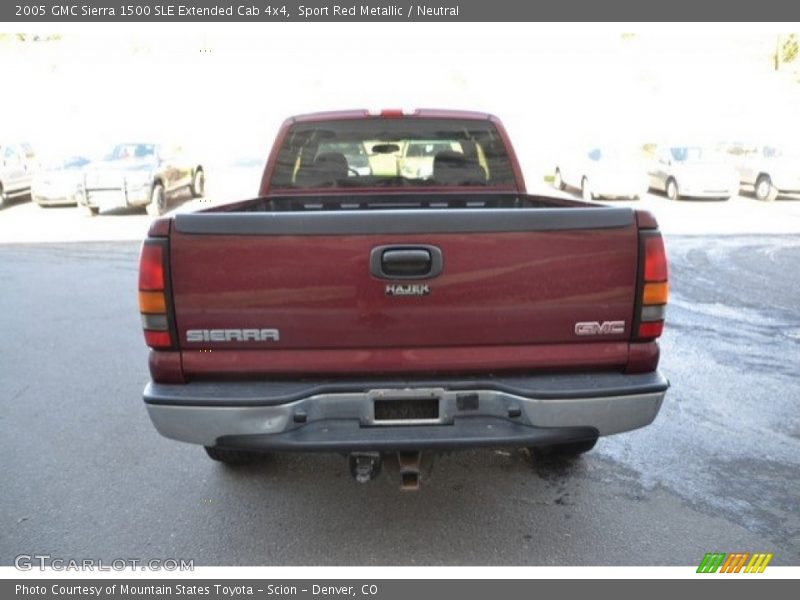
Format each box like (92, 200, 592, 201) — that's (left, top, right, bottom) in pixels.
(728, 144, 800, 201)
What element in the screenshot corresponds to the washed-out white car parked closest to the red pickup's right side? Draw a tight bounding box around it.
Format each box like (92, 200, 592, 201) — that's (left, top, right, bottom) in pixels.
(553, 147, 647, 200)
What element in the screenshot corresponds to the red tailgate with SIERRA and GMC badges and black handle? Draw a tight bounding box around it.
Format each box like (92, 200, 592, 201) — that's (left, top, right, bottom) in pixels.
(170, 206, 638, 376)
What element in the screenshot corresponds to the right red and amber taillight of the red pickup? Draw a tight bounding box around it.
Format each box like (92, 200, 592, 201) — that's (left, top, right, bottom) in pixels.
(636, 231, 669, 341)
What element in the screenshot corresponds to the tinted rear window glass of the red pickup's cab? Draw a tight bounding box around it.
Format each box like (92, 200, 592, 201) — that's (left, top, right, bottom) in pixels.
(270, 118, 514, 189)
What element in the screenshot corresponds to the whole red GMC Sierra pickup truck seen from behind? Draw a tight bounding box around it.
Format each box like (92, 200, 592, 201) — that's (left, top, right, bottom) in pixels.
(139, 110, 668, 489)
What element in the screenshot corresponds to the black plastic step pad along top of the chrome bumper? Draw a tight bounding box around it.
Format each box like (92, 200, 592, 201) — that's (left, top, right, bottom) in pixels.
(144, 371, 669, 406)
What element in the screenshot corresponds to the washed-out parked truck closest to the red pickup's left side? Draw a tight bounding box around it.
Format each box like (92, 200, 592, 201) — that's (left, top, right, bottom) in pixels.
(80, 143, 205, 215)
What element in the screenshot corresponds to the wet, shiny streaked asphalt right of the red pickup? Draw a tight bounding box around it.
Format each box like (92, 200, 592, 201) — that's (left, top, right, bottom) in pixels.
(603, 236, 800, 551)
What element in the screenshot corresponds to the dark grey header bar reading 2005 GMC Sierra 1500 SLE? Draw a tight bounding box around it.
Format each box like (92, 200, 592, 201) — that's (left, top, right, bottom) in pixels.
(6, 0, 800, 23)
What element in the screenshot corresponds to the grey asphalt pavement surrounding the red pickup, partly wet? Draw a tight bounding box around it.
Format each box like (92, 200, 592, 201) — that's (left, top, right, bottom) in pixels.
(0, 199, 800, 565)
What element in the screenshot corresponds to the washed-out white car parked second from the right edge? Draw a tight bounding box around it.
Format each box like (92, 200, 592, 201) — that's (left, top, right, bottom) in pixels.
(649, 146, 739, 200)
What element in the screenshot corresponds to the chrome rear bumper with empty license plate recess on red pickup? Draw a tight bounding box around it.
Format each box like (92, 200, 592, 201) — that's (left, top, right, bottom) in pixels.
(145, 373, 669, 451)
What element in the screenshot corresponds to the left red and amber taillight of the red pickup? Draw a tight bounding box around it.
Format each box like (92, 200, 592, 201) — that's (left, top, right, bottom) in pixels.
(139, 238, 174, 350)
